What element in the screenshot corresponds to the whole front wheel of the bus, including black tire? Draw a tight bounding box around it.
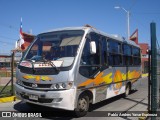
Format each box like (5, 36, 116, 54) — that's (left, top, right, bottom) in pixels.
(74, 95, 89, 117)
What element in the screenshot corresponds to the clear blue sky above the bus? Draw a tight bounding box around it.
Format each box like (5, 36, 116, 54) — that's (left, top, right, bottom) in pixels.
(0, 0, 160, 54)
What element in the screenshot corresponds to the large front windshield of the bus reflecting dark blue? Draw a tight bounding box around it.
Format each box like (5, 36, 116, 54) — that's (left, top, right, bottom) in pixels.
(23, 30, 84, 67)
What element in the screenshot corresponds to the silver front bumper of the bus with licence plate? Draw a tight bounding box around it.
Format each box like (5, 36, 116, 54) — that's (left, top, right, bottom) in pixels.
(14, 83, 76, 110)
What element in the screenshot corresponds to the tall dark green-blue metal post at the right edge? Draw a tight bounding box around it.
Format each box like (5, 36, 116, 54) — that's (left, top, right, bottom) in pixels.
(148, 22, 160, 120)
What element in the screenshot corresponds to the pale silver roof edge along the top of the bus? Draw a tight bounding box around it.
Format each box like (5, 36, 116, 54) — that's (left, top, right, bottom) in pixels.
(41, 26, 139, 47)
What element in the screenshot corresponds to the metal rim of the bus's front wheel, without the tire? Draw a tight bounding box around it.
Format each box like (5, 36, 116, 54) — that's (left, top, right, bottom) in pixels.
(78, 98, 88, 111)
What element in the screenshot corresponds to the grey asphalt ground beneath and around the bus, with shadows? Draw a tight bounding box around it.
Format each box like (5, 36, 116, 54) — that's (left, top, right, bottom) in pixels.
(0, 78, 148, 120)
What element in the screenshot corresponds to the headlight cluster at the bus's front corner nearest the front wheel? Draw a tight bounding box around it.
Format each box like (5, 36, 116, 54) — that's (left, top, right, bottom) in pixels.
(51, 82, 73, 90)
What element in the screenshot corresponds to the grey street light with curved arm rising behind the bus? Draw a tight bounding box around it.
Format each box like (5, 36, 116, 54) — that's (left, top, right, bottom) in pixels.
(114, 6, 130, 39)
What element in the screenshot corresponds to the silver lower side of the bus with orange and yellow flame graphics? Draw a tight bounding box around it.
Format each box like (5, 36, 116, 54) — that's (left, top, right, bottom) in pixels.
(77, 67, 141, 103)
